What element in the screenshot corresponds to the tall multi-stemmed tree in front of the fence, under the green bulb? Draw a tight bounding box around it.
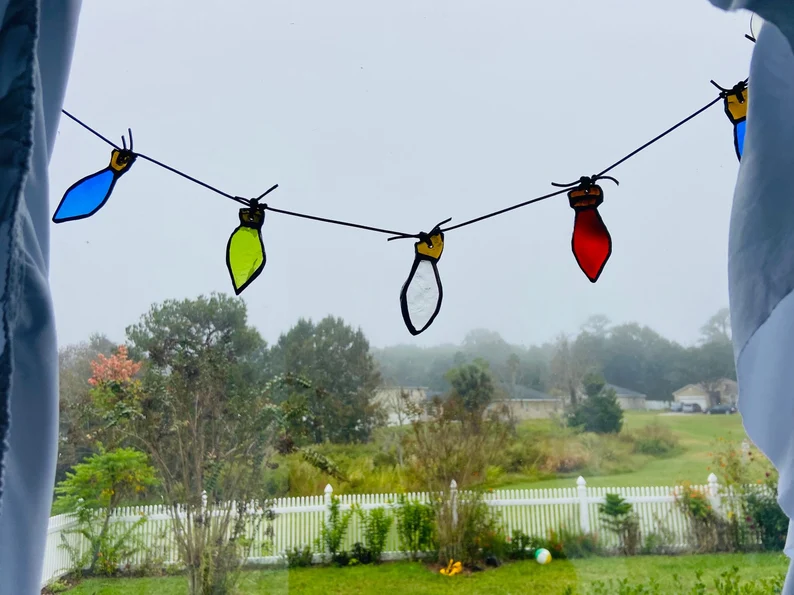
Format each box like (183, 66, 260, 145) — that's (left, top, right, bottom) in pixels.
(112, 294, 326, 595)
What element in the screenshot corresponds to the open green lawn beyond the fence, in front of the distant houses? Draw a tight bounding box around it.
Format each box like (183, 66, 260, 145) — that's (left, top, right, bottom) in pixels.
(499, 412, 747, 489)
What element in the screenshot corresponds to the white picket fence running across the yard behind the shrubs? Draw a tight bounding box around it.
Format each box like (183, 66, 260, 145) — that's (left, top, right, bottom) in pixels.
(41, 473, 736, 586)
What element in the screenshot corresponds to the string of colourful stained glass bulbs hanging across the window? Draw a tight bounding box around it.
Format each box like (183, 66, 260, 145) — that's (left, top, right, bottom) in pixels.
(52, 35, 755, 335)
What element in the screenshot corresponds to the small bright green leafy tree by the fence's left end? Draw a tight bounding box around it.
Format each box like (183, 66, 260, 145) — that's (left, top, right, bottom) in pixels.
(54, 444, 157, 573)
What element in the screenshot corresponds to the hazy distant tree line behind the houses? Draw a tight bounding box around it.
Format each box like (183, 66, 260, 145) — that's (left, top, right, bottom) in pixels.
(374, 308, 736, 400)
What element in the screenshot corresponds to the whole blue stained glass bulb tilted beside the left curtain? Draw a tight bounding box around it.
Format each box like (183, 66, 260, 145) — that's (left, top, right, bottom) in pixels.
(52, 149, 135, 223)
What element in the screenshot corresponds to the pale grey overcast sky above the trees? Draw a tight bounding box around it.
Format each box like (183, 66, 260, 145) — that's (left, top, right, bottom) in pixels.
(51, 0, 752, 346)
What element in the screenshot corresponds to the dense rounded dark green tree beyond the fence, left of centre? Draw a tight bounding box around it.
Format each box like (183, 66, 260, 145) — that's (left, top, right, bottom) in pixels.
(271, 316, 382, 443)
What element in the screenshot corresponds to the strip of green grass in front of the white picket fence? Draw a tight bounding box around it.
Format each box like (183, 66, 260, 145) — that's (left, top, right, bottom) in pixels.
(63, 554, 788, 595)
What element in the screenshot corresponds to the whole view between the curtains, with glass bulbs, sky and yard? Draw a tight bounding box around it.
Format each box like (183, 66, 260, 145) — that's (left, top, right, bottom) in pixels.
(41, 0, 788, 595)
